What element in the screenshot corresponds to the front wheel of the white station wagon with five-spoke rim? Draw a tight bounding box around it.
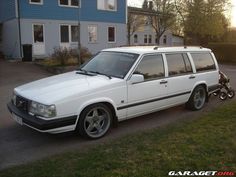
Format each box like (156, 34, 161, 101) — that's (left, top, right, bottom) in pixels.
(77, 103, 113, 139)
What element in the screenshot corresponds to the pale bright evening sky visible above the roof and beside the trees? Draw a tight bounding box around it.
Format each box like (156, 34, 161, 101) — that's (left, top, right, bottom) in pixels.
(128, 0, 236, 27)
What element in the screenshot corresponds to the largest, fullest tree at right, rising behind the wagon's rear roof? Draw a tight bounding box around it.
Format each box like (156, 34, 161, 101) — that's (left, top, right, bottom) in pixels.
(175, 0, 229, 44)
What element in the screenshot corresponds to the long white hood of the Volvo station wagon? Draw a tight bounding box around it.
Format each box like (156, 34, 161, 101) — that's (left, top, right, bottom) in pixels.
(14, 71, 123, 104)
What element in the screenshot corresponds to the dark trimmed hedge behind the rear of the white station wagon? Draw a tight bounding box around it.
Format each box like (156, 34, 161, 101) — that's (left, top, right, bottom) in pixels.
(207, 43, 236, 64)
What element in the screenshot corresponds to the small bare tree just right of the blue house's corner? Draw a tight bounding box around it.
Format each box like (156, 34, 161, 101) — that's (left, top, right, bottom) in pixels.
(127, 12, 143, 45)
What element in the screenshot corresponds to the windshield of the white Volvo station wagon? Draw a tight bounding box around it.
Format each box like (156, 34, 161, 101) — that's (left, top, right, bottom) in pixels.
(81, 52, 139, 79)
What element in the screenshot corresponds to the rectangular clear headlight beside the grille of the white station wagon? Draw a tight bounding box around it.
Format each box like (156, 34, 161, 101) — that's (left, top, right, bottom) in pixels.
(29, 101, 56, 118)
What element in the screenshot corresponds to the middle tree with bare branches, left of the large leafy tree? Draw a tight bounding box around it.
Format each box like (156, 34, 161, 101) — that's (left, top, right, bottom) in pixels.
(150, 0, 176, 44)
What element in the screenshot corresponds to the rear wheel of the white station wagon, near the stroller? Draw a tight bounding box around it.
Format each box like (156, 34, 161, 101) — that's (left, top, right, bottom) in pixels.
(186, 85, 207, 111)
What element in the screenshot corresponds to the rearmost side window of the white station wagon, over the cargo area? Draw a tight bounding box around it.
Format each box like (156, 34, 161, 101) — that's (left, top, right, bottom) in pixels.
(191, 53, 216, 71)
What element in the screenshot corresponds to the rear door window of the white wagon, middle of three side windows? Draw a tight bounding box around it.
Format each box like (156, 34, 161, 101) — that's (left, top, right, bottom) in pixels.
(166, 53, 192, 76)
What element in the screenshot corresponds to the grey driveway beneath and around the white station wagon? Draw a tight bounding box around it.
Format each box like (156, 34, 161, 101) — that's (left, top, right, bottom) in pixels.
(0, 60, 236, 170)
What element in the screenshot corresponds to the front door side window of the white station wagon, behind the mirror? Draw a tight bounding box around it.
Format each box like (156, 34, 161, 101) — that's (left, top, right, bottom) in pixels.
(134, 55, 165, 80)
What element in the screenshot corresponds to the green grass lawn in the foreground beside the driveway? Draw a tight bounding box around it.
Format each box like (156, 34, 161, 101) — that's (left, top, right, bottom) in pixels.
(0, 102, 236, 177)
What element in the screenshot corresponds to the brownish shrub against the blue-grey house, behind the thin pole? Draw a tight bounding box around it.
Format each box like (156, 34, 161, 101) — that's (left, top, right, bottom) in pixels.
(51, 47, 92, 66)
